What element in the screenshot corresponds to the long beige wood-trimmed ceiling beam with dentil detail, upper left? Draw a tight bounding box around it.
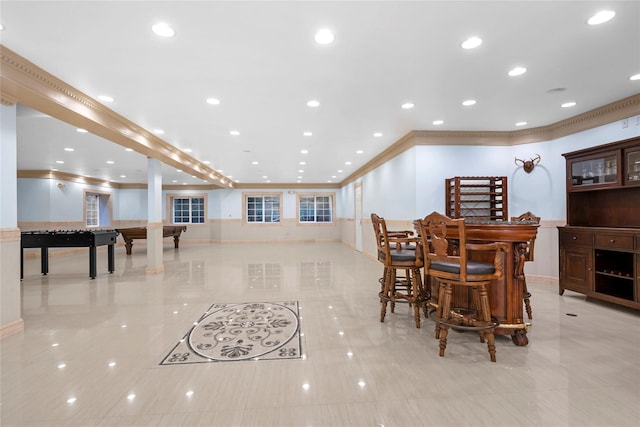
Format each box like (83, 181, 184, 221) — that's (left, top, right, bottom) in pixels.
(0, 44, 233, 188)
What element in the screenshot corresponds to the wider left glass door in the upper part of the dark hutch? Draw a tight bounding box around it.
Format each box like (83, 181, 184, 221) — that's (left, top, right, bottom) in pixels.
(570, 151, 620, 189)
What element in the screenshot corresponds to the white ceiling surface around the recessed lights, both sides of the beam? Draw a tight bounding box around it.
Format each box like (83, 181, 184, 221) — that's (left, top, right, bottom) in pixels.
(0, 0, 640, 184)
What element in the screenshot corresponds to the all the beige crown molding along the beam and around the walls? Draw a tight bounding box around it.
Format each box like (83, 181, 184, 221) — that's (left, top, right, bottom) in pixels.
(0, 44, 640, 189)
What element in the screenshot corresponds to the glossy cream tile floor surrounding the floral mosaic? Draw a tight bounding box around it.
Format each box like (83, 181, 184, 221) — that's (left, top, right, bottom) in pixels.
(0, 240, 640, 427)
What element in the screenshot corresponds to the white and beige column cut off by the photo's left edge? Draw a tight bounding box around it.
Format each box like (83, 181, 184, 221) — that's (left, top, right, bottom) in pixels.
(0, 105, 24, 338)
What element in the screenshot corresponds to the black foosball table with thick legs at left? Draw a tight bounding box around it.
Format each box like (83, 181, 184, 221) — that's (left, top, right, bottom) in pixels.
(20, 230, 118, 279)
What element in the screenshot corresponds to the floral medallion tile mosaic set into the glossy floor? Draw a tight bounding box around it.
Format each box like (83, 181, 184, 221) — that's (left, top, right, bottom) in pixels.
(160, 301, 303, 365)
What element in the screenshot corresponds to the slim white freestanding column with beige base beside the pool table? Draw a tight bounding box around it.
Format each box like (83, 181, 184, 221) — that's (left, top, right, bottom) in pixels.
(147, 157, 164, 274)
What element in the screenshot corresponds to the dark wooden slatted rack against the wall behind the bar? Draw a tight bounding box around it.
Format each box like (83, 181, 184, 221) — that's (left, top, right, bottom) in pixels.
(445, 176, 509, 221)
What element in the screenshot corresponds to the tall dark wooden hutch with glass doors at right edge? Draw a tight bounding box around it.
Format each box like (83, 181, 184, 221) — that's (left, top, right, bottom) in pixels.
(558, 138, 640, 309)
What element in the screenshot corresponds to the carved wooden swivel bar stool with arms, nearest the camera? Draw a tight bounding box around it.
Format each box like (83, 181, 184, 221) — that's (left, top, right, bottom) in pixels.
(416, 212, 508, 362)
